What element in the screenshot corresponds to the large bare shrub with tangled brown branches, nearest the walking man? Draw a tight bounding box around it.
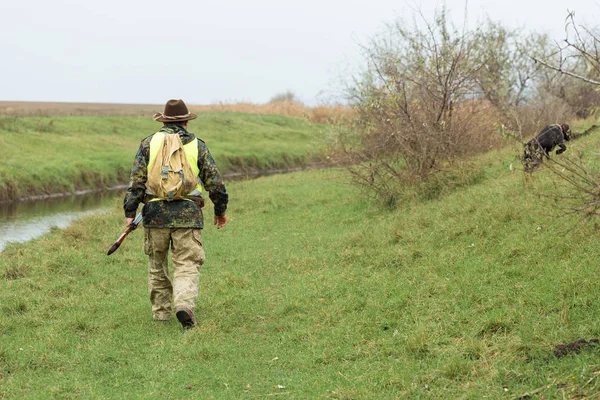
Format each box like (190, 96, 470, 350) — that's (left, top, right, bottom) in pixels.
(330, 10, 502, 205)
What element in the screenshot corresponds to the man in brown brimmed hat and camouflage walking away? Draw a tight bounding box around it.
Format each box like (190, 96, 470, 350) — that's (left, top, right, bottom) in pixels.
(123, 100, 228, 329)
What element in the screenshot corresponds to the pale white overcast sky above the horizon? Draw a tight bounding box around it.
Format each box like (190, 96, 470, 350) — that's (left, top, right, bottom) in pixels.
(0, 0, 600, 105)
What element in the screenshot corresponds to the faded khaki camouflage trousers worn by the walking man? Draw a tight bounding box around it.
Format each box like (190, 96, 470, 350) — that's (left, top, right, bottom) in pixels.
(144, 228, 205, 321)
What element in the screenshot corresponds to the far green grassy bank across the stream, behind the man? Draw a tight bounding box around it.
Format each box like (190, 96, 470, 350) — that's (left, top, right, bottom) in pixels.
(0, 113, 320, 201)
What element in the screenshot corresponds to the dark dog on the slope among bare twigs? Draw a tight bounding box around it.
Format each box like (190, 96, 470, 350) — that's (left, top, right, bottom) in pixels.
(523, 124, 571, 172)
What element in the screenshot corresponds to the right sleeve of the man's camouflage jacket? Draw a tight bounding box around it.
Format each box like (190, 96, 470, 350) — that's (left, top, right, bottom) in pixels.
(198, 140, 229, 217)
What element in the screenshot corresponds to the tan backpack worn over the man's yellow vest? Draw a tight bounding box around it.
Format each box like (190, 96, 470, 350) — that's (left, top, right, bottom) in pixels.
(146, 132, 198, 201)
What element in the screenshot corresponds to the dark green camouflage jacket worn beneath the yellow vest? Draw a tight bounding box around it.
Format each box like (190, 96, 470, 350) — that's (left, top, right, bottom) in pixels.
(123, 124, 228, 229)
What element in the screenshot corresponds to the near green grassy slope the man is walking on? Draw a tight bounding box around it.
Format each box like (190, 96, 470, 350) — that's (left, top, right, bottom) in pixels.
(0, 126, 600, 399)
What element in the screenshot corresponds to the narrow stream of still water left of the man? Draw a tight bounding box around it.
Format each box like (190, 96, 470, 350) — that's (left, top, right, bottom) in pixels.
(0, 190, 122, 252)
